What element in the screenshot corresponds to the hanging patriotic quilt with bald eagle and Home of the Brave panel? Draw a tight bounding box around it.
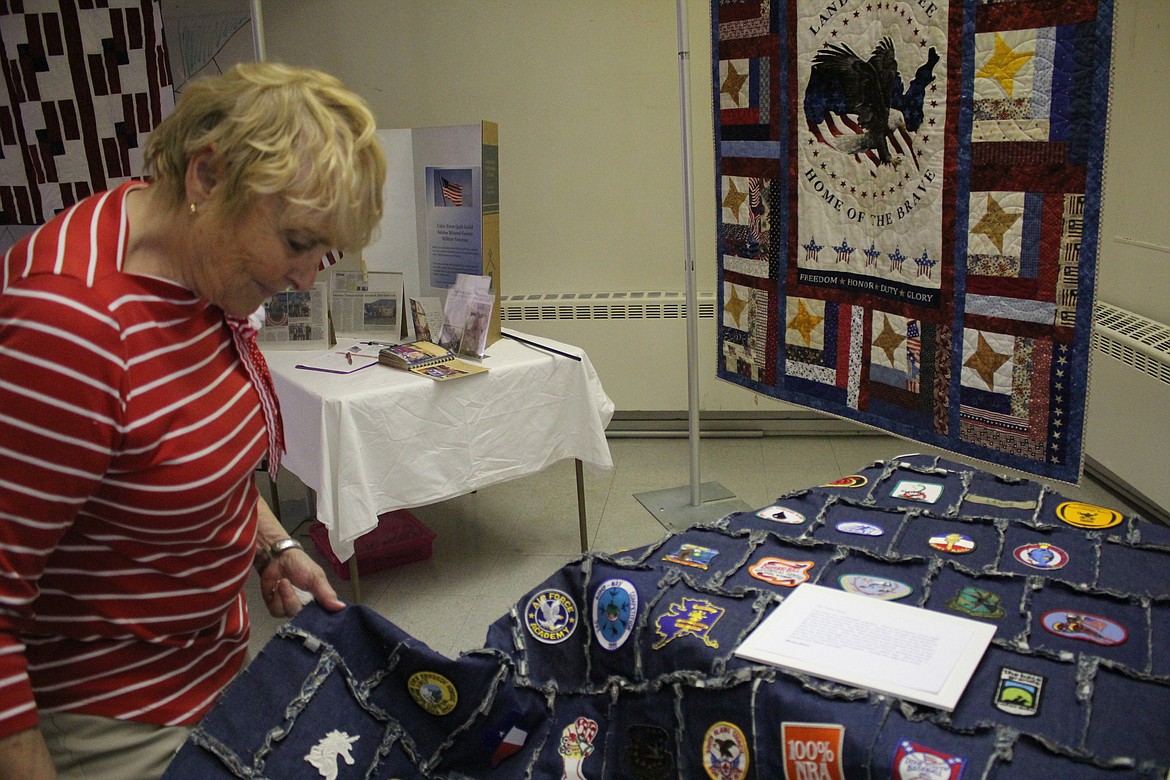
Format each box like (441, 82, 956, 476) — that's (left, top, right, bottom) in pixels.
(713, 0, 1113, 482)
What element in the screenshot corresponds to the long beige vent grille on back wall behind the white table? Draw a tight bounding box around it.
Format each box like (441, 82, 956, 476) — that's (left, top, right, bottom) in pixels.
(500, 292, 715, 323)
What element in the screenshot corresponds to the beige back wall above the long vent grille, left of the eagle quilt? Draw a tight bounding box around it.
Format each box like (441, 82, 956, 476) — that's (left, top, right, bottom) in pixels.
(263, 0, 715, 295)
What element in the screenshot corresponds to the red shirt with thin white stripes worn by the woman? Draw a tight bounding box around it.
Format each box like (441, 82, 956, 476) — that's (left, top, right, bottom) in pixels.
(0, 182, 267, 737)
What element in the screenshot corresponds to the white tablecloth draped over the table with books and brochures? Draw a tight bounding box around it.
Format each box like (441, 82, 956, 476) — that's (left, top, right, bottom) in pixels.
(264, 337, 613, 560)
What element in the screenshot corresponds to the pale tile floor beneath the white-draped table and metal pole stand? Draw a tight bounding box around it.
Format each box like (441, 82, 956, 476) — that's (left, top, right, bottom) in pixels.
(248, 435, 1135, 657)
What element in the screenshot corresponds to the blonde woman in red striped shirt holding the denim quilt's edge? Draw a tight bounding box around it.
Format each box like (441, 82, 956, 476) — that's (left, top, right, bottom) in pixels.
(0, 63, 385, 778)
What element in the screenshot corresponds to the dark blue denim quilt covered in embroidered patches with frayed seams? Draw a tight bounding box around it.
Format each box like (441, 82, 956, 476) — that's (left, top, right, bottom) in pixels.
(166, 455, 1170, 780)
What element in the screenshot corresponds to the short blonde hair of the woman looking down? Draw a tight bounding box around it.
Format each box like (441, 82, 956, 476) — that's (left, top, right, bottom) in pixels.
(145, 62, 386, 250)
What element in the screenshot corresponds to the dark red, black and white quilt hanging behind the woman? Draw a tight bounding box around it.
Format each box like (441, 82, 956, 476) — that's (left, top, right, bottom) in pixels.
(0, 0, 174, 225)
